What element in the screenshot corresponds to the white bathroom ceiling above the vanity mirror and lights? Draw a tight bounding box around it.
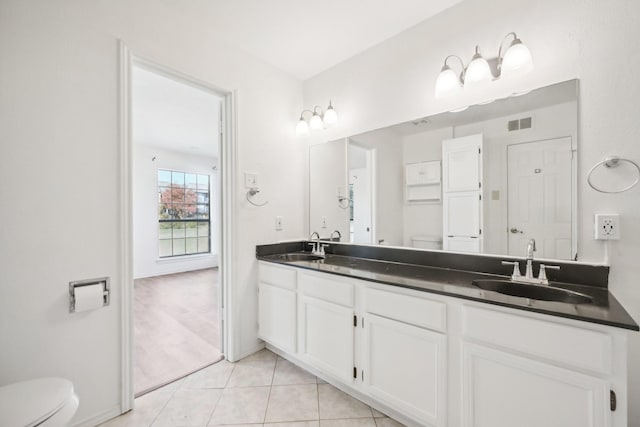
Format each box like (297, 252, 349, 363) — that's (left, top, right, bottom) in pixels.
(158, 0, 462, 80)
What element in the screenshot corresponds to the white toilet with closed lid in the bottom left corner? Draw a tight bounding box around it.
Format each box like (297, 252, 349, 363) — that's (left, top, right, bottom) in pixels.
(0, 378, 78, 427)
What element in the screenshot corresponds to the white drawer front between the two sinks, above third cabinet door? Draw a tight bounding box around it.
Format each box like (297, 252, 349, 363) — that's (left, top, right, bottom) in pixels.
(364, 288, 447, 332)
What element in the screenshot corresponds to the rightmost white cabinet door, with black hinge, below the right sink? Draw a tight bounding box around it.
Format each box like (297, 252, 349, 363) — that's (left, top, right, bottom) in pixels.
(462, 342, 611, 427)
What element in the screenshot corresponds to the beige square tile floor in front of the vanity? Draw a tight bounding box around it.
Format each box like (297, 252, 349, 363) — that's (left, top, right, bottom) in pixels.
(101, 350, 401, 427)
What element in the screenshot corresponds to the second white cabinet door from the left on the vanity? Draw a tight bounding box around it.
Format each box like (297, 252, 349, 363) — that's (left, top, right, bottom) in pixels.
(300, 296, 354, 382)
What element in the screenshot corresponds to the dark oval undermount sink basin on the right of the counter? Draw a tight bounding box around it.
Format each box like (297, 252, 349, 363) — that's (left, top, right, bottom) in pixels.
(472, 280, 593, 304)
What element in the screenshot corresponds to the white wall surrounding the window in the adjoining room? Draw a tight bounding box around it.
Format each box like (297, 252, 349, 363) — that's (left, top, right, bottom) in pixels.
(133, 143, 219, 279)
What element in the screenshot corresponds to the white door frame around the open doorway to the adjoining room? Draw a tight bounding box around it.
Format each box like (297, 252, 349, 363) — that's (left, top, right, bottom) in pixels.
(119, 40, 237, 413)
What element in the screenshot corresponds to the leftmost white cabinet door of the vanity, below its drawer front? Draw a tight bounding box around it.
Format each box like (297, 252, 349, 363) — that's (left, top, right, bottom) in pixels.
(258, 283, 297, 353)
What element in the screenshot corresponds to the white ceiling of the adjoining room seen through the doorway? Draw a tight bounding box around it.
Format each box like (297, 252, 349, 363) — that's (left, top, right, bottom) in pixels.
(131, 66, 222, 158)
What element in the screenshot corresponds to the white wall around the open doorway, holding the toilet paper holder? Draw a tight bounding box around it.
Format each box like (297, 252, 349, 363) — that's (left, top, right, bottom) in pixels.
(0, 0, 306, 423)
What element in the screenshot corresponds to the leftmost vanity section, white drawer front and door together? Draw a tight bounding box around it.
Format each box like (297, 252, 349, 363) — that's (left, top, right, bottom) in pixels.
(258, 262, 298, 353)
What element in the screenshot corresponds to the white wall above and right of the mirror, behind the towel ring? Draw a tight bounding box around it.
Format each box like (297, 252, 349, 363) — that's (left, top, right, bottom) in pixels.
(304, 0, 640, 425)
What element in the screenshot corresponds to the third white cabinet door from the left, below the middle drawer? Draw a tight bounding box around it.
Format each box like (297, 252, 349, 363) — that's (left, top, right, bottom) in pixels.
(363, 314, 447, 426)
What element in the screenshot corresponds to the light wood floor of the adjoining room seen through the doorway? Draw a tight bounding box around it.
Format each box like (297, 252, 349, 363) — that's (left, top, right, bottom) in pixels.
(134, 268, 222, 396)
